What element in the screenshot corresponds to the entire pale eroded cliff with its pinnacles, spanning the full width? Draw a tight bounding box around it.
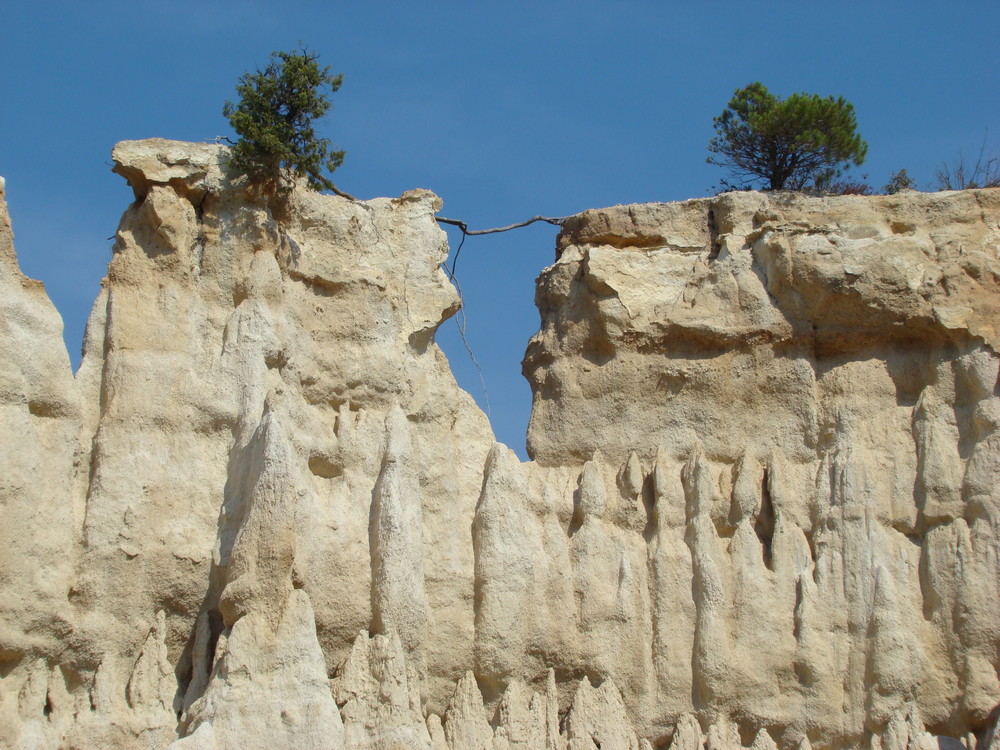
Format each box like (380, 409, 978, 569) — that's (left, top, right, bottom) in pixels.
(0, 140, 1000, 750)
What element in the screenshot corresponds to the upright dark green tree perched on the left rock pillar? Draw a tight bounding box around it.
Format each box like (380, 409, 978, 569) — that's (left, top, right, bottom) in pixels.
(222, 49, 344, 194)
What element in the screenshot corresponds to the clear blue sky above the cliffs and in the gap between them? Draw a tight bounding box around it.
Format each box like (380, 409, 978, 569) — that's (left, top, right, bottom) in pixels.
(0, 0, 1000, 456)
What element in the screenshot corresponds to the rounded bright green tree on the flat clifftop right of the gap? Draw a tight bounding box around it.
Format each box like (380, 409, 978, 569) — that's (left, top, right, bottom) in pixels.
(708, 82, 868, 190)
